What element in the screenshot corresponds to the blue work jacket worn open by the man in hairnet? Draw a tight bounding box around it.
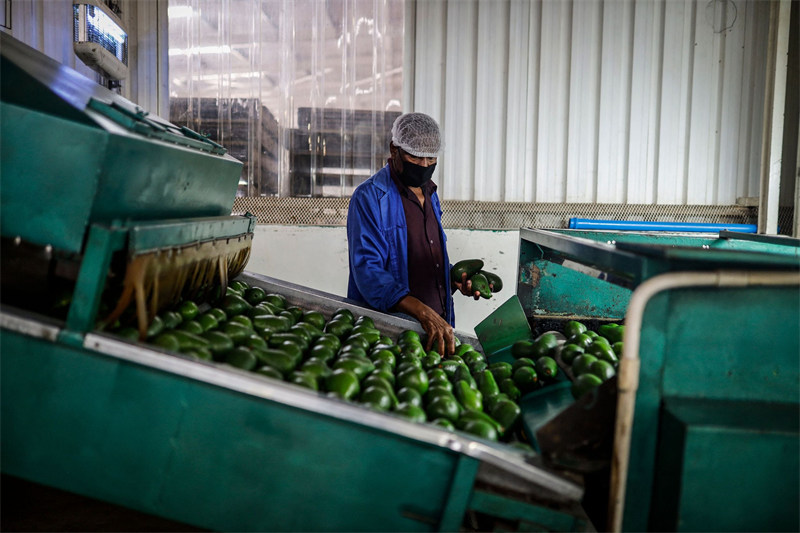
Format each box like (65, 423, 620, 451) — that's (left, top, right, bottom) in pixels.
(347, 165, 455, 326)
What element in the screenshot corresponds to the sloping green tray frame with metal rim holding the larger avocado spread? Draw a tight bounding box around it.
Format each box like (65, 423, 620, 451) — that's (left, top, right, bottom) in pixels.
(0, 273, 590, 531)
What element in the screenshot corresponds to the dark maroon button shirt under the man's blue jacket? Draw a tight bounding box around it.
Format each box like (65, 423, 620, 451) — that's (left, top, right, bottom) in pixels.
(389, 160, 449, 317)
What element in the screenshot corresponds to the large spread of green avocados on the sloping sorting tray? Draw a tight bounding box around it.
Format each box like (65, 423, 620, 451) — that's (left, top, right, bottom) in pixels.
(106, 280, 539, 444)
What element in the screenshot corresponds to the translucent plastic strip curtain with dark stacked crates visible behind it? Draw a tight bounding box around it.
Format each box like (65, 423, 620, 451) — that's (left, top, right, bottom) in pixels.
(169, 0, 404, 197)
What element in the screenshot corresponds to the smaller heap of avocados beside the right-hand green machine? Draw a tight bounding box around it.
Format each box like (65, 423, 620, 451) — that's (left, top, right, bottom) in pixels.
(511, 320, 625, 399)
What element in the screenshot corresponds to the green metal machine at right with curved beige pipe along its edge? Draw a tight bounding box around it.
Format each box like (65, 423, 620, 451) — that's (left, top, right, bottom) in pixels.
(484, 229, 800, 531)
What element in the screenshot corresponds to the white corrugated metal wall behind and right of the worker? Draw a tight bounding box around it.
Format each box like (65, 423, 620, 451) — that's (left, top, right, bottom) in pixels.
(404, 0, 769, 205)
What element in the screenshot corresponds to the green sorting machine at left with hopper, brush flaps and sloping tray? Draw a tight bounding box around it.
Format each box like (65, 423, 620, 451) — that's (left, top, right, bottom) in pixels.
(0, 34, 591, 531)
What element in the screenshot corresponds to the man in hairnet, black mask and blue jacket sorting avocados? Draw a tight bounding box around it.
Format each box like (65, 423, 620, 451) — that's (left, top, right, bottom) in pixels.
(347, 113, 480, 354)
